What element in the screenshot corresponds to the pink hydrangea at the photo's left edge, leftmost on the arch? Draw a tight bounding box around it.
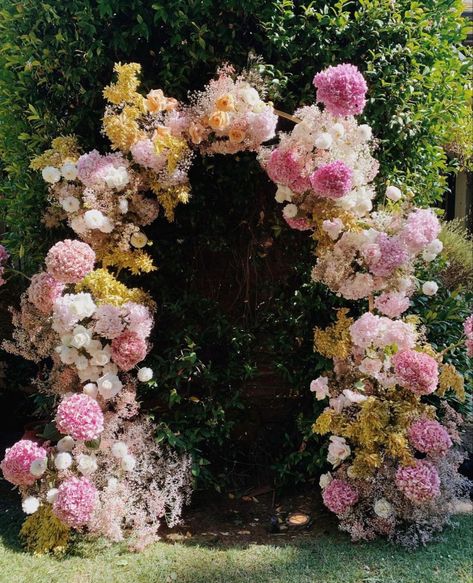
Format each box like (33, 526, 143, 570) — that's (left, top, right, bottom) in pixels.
(0, 439, 47, 486)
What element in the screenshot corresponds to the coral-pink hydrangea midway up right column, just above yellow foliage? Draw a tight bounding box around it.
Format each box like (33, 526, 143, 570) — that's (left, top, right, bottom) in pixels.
(392, 350, 439, 395)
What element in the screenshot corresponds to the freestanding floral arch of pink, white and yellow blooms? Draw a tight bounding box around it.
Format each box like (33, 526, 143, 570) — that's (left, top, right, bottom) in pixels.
(1, 63, 473, 551)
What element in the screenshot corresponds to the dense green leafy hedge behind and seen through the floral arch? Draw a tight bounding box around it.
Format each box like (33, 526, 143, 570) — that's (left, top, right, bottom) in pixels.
(0, 0, 471, 488)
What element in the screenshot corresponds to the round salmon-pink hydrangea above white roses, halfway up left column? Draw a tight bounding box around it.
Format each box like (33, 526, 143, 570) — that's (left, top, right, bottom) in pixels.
(46, 239, 95, 283)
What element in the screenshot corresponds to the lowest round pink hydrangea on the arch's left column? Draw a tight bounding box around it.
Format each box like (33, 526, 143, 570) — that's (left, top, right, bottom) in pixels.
(53, 477, 97, 528)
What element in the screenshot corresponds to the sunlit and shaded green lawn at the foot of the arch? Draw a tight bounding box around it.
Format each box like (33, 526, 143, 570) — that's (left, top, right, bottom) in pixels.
(0, 498, 473, 583)
